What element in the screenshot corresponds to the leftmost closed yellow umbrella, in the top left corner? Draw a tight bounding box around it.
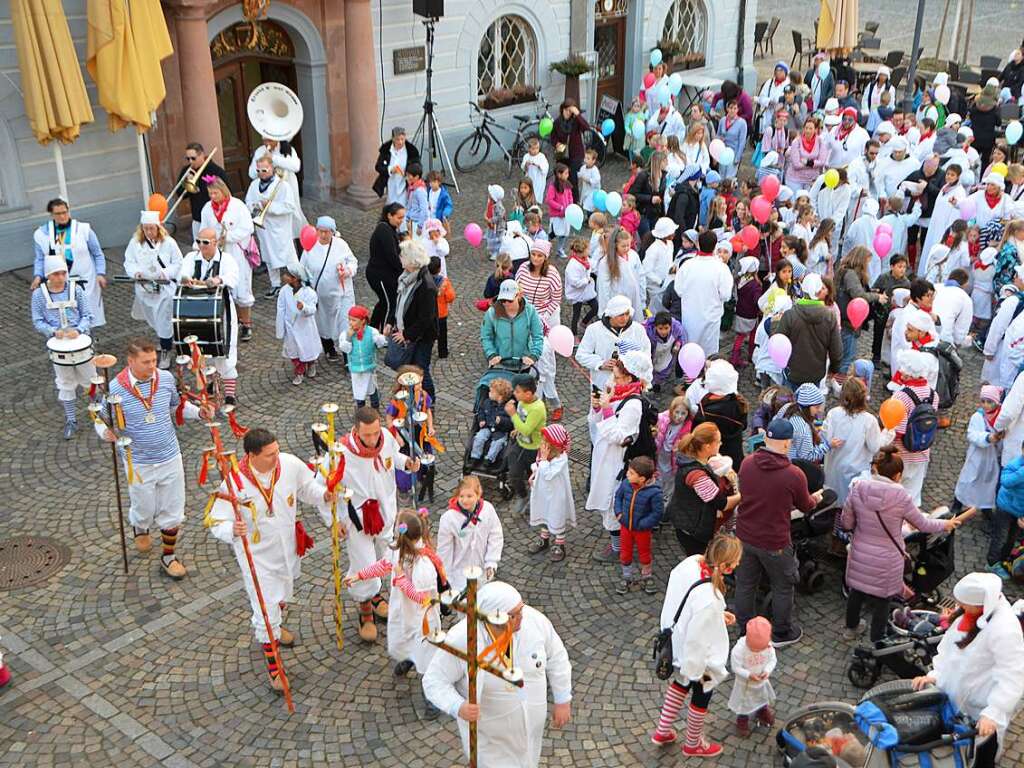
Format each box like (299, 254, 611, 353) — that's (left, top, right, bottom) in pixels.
(10, 0, 93, 144)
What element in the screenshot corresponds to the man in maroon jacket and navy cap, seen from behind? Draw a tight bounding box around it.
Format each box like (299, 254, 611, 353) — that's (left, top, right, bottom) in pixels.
(736, 419, 822, 648)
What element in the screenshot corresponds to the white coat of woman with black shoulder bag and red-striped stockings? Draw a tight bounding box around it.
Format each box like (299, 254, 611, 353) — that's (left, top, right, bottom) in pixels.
(660, 555, 729, 691)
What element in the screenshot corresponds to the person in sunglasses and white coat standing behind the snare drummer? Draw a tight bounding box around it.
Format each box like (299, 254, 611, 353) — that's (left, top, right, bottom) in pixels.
(32, 198, 106, 328)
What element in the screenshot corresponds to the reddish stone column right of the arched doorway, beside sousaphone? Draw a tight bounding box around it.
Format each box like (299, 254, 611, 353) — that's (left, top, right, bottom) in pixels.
(345, 0, 380, 208)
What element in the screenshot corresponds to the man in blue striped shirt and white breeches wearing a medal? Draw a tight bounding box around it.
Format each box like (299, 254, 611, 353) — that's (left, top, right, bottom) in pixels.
(95, 339, 213, 580)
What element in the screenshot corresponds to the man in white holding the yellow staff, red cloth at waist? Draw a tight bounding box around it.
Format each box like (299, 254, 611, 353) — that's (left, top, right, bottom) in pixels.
(339, 406, 420, 643)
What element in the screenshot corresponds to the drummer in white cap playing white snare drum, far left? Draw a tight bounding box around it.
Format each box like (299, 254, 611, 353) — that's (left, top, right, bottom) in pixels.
(32, 254, 96, 440)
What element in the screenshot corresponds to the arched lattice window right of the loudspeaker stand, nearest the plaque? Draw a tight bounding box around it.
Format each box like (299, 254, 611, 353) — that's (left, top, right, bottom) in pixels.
(476, 15, 537, 98)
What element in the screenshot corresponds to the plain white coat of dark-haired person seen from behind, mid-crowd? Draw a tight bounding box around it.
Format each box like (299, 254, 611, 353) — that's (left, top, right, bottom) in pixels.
(675, 253, 732, 354)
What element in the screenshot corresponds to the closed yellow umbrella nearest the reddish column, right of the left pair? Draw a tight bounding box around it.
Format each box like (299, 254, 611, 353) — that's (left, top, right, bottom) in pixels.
(86, 0, 173, 133)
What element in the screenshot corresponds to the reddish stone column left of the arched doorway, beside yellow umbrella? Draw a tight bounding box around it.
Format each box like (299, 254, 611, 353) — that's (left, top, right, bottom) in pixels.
(170, 0, 223, 156)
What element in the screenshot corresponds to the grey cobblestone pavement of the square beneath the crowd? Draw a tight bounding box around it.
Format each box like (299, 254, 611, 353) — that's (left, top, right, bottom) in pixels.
(0, 153, 1024, 768)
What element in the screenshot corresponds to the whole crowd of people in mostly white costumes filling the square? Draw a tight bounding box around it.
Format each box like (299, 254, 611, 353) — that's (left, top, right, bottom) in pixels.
(24, 39, 1024, 766)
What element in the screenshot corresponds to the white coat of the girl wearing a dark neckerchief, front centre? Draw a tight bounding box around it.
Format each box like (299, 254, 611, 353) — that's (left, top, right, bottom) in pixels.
(437, 501, 505, 594)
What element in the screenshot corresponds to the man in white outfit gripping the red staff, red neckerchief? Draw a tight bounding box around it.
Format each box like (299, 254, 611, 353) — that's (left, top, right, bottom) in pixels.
(204, 428, 335, 691)
